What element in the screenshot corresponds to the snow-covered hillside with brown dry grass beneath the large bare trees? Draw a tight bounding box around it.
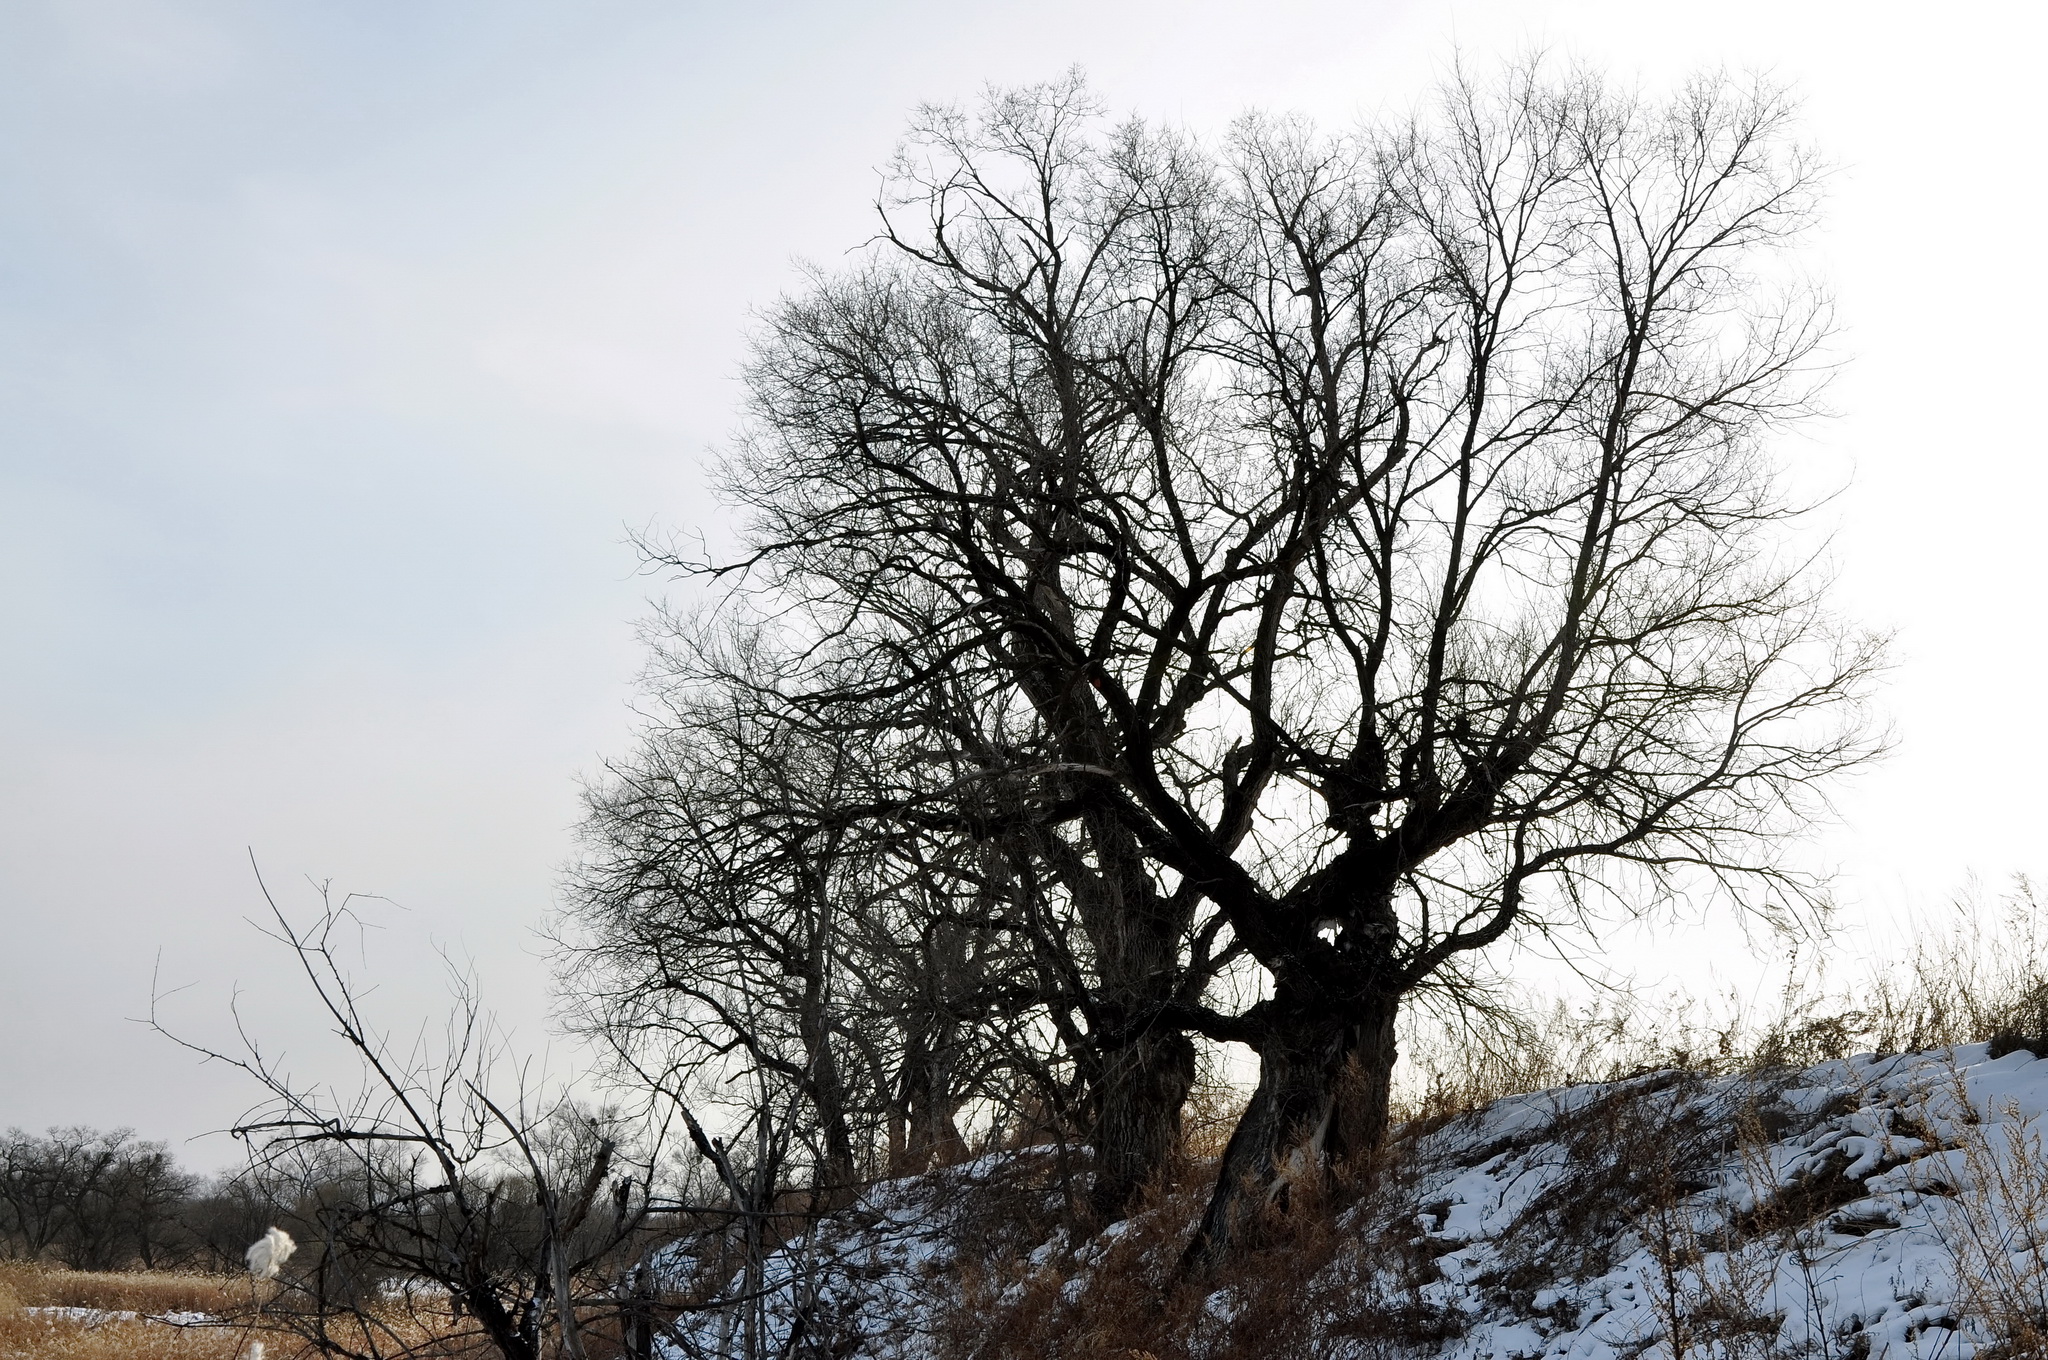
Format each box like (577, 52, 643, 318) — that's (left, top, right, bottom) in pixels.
(670, 1045, 2048, 1360)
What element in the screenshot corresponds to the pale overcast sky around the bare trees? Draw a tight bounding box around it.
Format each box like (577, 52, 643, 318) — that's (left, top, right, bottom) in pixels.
(0, 0, 2048, 1165)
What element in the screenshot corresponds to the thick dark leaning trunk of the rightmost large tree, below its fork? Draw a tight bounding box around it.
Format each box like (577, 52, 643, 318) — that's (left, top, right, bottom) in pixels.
(1182, 987, 1401, 1270)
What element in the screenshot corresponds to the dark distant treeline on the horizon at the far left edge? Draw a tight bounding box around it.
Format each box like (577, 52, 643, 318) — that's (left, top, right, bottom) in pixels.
(0, 1127, 279, 1270)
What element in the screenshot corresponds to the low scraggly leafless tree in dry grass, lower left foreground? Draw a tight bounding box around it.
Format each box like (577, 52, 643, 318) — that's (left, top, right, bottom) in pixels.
(158, 880, 657, 1360)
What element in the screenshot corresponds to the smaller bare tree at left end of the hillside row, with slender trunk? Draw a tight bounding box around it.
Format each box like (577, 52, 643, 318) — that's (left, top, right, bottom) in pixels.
(565, 663, 881, 1200)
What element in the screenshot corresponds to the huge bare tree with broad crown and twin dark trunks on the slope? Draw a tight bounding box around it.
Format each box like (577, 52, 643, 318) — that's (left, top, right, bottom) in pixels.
(668, 66, 1878, 1258)
